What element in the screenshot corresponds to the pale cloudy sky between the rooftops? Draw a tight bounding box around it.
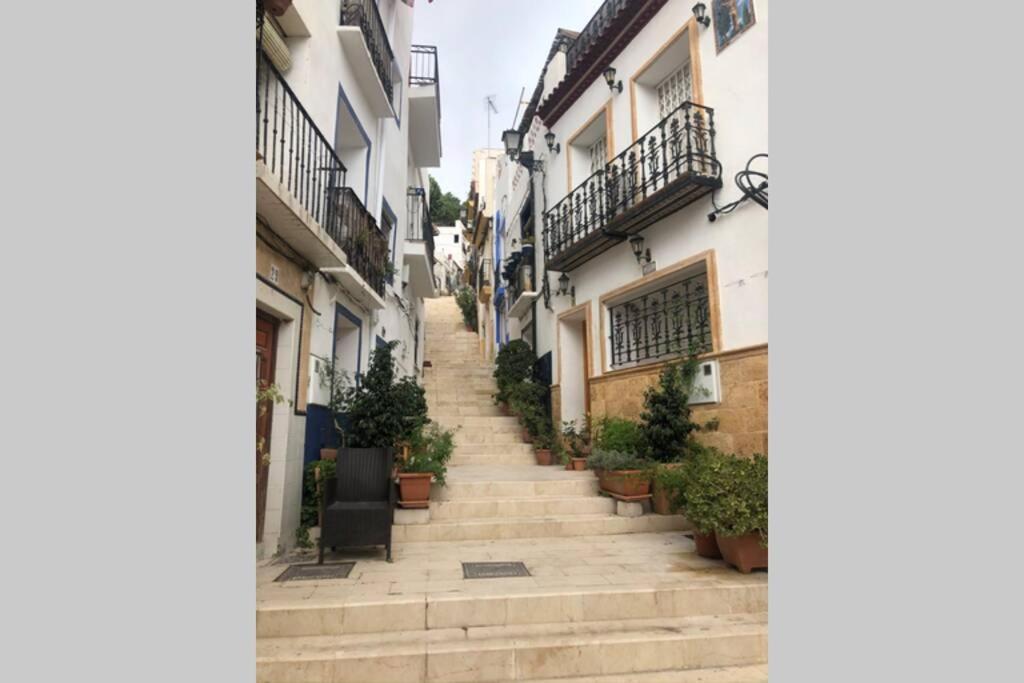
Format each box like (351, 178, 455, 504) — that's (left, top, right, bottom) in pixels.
(413, 0, 602, 199)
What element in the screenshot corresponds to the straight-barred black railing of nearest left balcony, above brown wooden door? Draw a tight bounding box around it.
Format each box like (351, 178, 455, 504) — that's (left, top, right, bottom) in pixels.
(256, 49, 346, 235)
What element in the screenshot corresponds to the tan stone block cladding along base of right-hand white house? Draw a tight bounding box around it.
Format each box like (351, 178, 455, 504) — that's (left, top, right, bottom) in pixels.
(585, 344, 768, 456)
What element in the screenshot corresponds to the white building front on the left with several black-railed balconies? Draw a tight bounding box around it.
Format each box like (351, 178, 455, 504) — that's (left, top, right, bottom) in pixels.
(256, 0, 441, 555)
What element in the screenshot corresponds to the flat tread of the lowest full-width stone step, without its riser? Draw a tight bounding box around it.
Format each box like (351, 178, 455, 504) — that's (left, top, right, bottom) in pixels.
(256, 612, 768, 661)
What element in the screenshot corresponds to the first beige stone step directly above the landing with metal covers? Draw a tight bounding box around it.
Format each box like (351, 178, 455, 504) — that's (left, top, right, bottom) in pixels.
(392, 515, 687, 543)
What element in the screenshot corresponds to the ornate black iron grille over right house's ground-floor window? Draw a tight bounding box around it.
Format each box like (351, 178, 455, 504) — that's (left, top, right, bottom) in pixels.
(608, 272, 712, 368)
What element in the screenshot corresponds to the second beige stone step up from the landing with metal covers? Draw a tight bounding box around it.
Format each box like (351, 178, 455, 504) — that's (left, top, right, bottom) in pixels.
(430, 495, 615, 521)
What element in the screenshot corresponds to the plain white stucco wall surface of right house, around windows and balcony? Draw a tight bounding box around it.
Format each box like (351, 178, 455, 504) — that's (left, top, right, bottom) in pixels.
(536, 0, 769, 385)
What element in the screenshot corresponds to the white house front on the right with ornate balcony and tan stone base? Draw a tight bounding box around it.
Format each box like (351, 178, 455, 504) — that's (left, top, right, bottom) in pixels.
(495, 0, 769, 454)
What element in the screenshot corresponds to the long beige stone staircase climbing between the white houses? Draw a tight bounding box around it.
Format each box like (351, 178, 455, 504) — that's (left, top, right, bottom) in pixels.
(256, 298, 768, 683)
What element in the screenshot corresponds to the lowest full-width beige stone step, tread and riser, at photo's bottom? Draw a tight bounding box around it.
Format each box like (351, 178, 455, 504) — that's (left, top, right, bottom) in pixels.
(256, 613, 768, 683)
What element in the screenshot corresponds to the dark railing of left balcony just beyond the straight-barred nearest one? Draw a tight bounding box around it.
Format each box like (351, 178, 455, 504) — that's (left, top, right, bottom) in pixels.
(328, 187, 388, 296)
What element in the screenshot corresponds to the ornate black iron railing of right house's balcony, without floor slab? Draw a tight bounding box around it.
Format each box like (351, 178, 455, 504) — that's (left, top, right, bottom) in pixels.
(544, 101, 720, 261)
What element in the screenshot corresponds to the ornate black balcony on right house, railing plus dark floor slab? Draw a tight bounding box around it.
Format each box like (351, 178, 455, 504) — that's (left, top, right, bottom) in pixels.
(544, 102, 722, 270)
